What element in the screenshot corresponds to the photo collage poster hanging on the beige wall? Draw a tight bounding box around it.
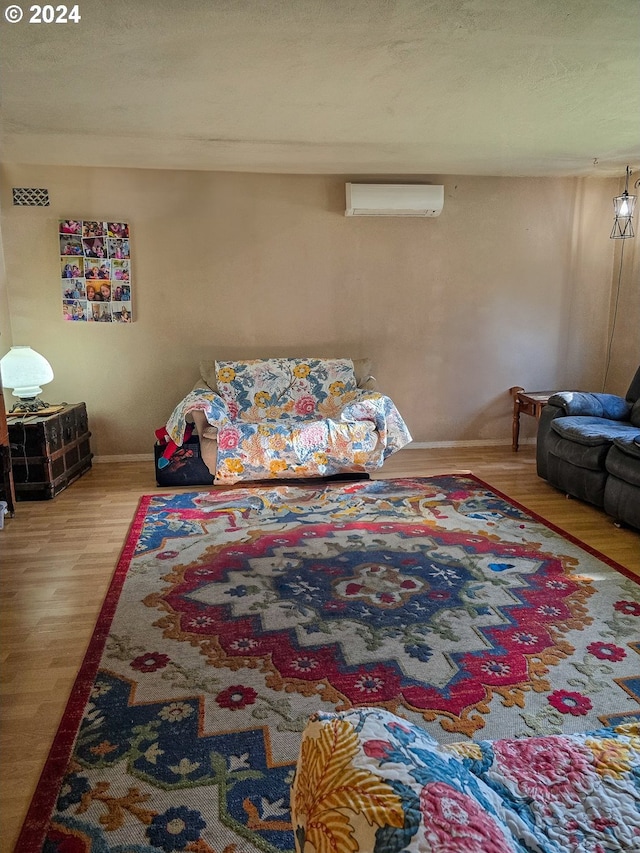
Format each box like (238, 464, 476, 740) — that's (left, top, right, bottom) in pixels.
(58, 219, 133, 323)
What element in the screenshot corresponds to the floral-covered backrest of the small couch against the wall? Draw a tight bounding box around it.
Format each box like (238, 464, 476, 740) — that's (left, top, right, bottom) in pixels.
(216, 358, 358, 423)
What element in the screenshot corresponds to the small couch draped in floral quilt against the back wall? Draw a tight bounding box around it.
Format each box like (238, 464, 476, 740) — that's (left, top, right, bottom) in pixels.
(166, 358, 411, 484)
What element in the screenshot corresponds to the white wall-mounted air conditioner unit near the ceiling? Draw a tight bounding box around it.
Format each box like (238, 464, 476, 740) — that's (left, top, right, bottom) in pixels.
(345, 184, 444, 216)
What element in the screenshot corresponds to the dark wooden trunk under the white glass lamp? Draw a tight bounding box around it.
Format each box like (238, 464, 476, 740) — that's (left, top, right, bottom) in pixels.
(9, 403, 93, 500)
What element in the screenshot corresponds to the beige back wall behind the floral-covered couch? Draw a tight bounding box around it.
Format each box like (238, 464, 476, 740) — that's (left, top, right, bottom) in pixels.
(0, 166, 640, 456)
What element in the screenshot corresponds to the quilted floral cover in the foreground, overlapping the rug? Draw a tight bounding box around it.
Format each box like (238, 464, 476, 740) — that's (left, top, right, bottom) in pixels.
(291, 709, 640, 853)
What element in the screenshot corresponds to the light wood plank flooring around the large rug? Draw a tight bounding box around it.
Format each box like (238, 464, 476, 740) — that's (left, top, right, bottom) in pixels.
(0, 446, 640, 853)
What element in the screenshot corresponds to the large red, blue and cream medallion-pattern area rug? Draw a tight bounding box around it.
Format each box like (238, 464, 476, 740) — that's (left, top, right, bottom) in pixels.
(17, 476, 640, 853)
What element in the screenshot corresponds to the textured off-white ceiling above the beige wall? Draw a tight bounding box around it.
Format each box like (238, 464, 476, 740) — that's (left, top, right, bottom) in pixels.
(0, 0, 640, 176)
